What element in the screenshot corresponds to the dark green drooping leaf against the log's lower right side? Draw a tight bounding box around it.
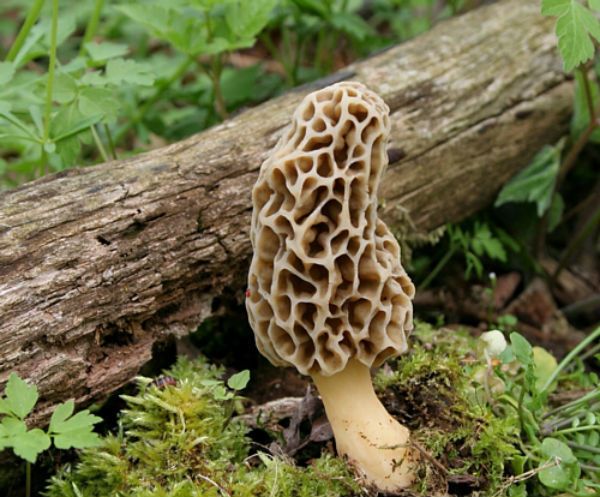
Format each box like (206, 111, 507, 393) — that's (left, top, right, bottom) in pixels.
(494, 140, 564, 217)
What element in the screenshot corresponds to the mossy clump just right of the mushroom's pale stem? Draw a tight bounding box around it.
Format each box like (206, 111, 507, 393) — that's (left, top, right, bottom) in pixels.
(375, 324, 518, 495)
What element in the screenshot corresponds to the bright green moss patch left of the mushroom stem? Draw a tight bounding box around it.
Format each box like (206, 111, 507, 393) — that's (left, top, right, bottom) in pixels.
(46, 361, 359, 497)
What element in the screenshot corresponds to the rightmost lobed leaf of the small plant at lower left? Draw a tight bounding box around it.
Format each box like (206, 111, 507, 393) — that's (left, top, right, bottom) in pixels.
(48, 400, 102, 449)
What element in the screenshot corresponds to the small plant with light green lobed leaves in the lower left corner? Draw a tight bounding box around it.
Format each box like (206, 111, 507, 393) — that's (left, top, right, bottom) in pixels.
(0, 373, 102, 497)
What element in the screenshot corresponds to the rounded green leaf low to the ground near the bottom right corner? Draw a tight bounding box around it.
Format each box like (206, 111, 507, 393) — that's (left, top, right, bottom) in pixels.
(538, 438, 581, 490)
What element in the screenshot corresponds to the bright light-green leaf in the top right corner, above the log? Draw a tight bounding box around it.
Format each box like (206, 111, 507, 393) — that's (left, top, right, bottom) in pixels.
(542, 0, 600, 71)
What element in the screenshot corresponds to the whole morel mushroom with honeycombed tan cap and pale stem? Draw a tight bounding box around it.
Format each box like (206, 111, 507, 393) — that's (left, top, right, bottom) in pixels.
(246, 82, 415, 492)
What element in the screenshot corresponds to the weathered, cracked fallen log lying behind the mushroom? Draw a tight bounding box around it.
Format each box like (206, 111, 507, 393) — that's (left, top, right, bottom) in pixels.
(0, 0, 572, 415)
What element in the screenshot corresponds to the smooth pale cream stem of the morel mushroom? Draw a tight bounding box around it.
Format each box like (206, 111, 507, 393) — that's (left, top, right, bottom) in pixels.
(312, 359, 415, 492)
